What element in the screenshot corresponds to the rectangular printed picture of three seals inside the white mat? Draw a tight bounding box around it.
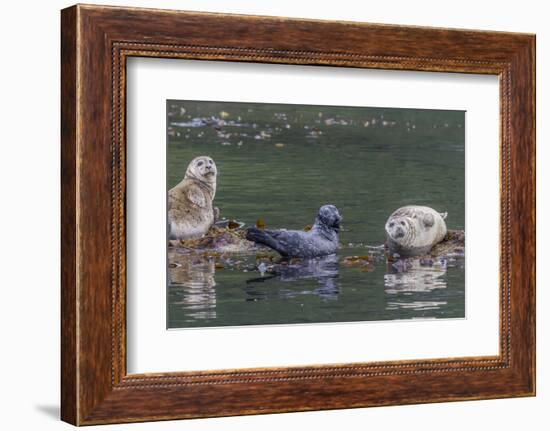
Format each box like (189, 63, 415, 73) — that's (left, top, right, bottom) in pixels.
(167, 99, 466, 329)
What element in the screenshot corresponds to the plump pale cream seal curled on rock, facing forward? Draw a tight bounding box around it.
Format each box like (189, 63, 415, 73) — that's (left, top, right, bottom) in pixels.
(386, 205, 447, 257)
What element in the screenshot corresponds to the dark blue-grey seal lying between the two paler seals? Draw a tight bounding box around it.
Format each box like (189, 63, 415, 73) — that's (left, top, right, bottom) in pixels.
(246, 205, 342, 257)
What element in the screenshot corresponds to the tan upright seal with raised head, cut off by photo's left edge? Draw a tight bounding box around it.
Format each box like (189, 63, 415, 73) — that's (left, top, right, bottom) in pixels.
(168, 156, 218, 239)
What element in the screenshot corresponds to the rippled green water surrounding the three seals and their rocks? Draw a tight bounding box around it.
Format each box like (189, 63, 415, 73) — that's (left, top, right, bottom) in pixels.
(167, 101, 465, 328)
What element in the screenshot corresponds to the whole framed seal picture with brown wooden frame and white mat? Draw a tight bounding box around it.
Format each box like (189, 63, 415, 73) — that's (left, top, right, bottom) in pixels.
(61, 5, 535, 425)
